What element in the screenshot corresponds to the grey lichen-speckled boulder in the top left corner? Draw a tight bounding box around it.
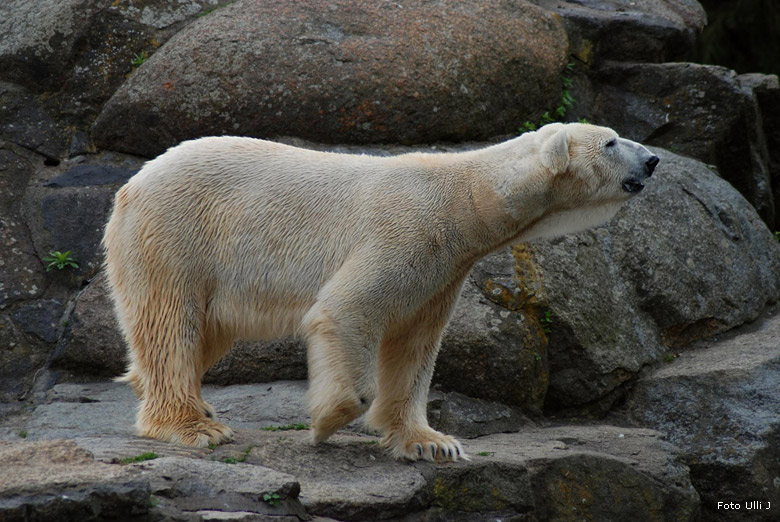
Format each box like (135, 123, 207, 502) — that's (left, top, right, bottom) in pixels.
(0, 0, 235, 133)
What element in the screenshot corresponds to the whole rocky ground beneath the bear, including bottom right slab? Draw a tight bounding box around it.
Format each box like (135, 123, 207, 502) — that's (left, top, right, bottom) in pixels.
(0, 304, 780, 521)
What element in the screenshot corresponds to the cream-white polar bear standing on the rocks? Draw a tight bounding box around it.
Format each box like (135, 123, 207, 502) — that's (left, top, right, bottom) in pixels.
(104, 124, 658, 460)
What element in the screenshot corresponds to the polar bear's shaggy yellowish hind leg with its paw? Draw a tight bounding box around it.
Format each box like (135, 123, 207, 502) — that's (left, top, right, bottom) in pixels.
(132, 295, 233, 447)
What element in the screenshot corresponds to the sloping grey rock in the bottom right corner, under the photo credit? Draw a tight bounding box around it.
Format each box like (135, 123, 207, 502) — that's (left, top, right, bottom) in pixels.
(623, 307, 780, 522)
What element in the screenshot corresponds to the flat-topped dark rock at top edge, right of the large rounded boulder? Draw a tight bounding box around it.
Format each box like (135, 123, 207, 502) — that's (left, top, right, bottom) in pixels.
(533, 0, 707, 64)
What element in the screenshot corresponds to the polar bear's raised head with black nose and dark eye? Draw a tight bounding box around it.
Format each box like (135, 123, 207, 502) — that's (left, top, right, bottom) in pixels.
(523, 123, 659, 240)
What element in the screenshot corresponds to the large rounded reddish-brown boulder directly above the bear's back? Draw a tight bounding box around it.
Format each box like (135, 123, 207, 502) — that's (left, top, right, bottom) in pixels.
(94, 0, 567, 156)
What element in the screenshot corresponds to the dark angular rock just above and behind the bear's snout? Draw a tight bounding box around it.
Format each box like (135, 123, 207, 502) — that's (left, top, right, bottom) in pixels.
(577, 62, 775, 227)
